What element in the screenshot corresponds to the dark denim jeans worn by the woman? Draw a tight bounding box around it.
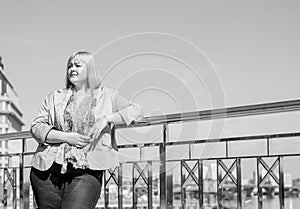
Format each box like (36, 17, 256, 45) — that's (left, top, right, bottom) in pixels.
(30, 163, 104, 209)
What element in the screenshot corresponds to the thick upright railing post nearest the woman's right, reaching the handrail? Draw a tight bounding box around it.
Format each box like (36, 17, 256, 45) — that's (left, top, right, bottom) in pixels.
(159, 124, 168, 208)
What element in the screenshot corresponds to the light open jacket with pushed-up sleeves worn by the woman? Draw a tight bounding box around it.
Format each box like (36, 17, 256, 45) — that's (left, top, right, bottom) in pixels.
(30, 86, 143, 170)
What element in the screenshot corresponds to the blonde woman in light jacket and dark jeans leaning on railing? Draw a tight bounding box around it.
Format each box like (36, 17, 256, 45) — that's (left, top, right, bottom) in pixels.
(30, 51, 142, 209)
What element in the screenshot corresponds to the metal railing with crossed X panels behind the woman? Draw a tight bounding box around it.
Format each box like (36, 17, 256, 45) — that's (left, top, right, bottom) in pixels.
(0, 100, 300, 209)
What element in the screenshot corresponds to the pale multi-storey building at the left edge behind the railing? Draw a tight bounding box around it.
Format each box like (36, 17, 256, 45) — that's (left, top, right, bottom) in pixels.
(0, 57, 24, 167)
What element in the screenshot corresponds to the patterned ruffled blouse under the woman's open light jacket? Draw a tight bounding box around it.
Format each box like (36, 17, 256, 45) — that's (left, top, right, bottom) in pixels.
(55, 89, 97, 173)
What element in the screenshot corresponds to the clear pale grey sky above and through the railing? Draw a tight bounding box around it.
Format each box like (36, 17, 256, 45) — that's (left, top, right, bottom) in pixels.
(0, 0, 300, 180)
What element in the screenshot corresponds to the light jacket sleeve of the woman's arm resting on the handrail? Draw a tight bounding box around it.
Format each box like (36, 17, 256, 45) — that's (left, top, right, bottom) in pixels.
(112, 90, 143, 126)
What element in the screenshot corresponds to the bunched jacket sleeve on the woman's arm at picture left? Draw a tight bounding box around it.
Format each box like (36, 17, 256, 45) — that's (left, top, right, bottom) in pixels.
(30, 94, 54, 144)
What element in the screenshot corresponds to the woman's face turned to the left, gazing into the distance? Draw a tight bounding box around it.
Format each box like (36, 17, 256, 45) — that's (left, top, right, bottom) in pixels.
(68, 58, 87, 87)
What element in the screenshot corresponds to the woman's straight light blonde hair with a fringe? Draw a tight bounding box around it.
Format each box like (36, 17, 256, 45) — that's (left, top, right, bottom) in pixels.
(66, 51, 101, 89)
